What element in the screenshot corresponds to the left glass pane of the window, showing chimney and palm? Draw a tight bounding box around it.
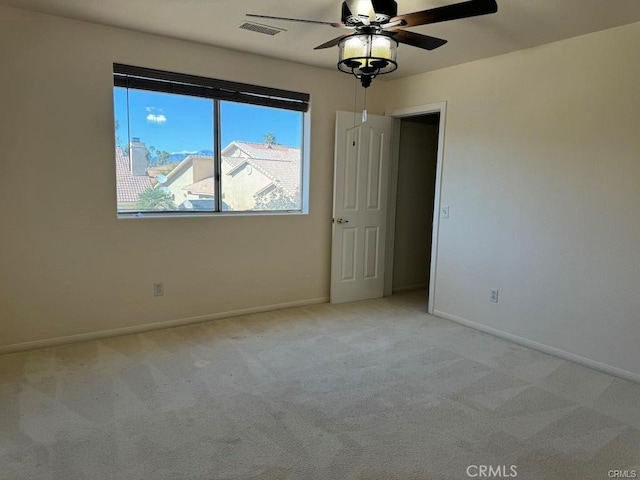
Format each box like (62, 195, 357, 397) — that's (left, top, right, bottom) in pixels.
(114, 87, 215, 212)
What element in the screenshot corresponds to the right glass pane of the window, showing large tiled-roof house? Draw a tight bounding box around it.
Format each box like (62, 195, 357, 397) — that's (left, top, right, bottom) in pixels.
(220, 101, 303, 211)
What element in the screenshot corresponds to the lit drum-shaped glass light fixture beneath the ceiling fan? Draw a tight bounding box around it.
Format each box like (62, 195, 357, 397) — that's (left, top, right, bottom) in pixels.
(338, 32, 398, 88)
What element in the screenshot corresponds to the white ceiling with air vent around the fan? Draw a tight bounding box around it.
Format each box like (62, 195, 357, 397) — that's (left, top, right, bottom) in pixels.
(0, 0, 640, 78)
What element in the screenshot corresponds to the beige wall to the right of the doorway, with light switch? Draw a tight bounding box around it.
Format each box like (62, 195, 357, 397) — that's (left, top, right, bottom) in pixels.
(385, 23, 640, 379)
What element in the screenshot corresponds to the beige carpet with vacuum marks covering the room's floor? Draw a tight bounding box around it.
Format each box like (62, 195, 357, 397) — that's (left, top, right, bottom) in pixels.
(0, 292, 640, 480)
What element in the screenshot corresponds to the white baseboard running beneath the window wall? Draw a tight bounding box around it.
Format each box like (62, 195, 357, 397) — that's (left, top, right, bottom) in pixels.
(0, 297, 329, 355)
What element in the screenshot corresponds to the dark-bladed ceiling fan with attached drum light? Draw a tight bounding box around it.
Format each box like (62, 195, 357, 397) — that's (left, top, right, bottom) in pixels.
(247, 0, 498, 87)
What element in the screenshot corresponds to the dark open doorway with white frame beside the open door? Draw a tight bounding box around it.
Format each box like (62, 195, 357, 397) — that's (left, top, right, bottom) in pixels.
(385, 103, 446, 313)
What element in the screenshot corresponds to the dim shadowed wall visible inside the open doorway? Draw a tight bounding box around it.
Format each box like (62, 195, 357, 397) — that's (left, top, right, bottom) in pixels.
(393, 119, 438, 291)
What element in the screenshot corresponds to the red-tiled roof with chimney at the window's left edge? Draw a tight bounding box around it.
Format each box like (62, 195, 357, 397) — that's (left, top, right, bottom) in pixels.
(116, 141, 152, 211)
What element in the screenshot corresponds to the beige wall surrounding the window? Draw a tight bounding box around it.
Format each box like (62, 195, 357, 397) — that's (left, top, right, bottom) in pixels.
(0, 7, 380, 347)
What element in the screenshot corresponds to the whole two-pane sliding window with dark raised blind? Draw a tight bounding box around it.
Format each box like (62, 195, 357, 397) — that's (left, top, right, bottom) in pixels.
(113, 64, 309, 216)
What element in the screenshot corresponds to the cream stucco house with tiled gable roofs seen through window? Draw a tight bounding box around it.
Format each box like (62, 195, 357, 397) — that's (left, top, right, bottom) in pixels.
(164, 141, 301, 211)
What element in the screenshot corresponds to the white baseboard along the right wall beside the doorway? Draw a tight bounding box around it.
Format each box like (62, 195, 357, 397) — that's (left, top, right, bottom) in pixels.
(433, 310, 640, 383)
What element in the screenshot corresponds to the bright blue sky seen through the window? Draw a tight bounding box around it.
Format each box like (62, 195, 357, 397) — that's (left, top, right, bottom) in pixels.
(114, 87, 302, 153)
